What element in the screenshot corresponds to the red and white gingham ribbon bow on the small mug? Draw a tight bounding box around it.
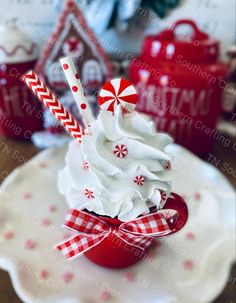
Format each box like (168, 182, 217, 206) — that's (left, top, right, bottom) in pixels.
(57, 209, 177, 259)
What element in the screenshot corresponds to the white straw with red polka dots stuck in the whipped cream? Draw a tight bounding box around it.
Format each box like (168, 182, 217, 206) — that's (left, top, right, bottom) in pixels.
(60, 56, 94, 128)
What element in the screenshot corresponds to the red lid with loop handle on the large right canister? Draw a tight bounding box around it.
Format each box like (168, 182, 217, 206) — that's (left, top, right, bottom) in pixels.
(142, 19, 219, 63)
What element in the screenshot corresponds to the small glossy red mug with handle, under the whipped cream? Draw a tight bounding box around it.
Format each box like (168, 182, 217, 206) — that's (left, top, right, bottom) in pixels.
(84, 193, 188, 268)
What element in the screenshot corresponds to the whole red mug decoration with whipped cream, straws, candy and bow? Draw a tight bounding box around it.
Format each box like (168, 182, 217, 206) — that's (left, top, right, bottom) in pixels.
(22, 57, 188, 268)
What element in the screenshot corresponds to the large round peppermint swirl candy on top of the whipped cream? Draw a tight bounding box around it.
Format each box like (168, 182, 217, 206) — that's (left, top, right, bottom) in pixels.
(98, 78, 137, 114)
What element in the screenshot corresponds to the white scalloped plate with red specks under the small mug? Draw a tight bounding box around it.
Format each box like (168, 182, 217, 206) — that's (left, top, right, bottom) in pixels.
(0, 145, 235, 303)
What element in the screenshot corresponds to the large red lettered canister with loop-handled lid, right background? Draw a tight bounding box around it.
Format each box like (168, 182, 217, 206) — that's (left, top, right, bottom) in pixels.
(130, 20, 227, 155)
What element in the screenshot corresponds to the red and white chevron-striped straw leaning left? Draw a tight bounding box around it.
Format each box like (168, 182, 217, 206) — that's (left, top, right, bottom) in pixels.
(22, 71, 84, 142)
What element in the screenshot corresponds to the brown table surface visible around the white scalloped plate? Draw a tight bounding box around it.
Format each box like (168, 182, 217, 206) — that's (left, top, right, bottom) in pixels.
(0, 137, 236, 303)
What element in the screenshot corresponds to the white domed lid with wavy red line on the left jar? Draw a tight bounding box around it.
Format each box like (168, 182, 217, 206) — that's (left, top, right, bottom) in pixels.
(0, 21, 38, 63)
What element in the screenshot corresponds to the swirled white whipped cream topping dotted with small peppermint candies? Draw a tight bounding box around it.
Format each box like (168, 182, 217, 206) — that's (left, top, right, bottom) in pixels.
(58, 106, 172, 221)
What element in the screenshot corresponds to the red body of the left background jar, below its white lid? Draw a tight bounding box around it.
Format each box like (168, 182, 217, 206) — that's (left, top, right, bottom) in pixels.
(0, 61, 43, 140)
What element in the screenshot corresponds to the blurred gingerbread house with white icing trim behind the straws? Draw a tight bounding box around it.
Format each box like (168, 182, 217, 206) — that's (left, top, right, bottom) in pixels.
(36, 0, 112, 103)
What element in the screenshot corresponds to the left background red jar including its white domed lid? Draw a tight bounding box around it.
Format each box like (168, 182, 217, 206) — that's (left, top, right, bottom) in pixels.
(0, 22, 43, 140)
